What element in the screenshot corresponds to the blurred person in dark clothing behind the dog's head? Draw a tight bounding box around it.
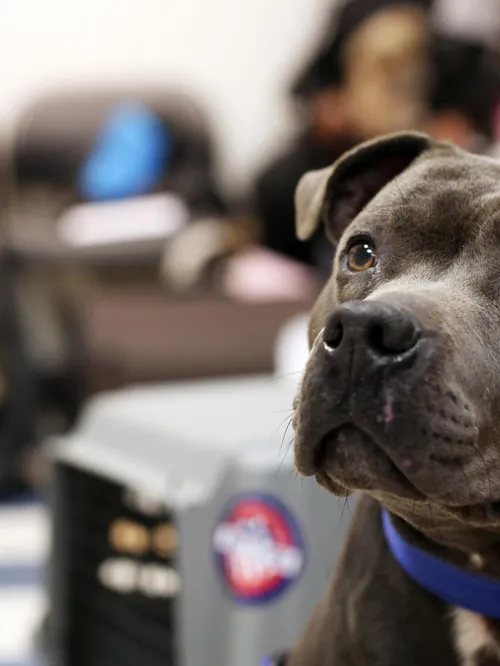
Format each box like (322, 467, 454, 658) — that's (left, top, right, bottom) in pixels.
(255, 0, 499, 271)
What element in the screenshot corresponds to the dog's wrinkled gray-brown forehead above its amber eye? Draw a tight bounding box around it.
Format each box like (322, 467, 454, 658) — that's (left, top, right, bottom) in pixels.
(354, 157, 500, 258)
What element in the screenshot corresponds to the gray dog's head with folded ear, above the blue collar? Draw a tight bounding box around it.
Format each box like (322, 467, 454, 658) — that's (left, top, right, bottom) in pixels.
(294, 133, 500, 551)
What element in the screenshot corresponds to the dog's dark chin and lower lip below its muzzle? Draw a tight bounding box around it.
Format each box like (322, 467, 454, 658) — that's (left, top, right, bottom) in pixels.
(316, 425, 425, 500)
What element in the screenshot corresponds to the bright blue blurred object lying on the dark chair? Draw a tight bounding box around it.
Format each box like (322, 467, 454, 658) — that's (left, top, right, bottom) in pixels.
(78, 102, 173, 201)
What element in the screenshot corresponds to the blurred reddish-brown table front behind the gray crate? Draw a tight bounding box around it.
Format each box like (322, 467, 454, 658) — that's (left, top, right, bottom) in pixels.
(79, 288, 311, 393)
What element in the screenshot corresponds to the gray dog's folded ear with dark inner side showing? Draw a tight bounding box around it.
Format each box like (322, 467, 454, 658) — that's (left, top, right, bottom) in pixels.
(295, 132, 433, 242)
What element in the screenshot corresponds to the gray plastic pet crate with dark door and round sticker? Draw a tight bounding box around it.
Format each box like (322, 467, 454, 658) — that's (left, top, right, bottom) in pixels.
(49, 376, 349, 666)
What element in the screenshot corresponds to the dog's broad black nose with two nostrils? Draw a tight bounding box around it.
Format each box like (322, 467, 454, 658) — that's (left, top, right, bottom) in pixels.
(323, 301, 418, 361)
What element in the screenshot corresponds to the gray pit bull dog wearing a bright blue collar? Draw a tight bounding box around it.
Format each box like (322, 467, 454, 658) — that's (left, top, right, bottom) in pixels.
(287, 133, 500, 666)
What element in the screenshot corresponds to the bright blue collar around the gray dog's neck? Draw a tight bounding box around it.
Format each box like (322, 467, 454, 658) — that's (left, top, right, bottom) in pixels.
(382, 509, 500, 619)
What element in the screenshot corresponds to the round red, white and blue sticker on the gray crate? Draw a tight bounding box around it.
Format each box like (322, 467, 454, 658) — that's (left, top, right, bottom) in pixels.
(213, 494, 305, 604)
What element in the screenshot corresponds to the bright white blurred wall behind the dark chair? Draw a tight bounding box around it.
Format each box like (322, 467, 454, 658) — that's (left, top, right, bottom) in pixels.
(0, 0, 332, 192)
